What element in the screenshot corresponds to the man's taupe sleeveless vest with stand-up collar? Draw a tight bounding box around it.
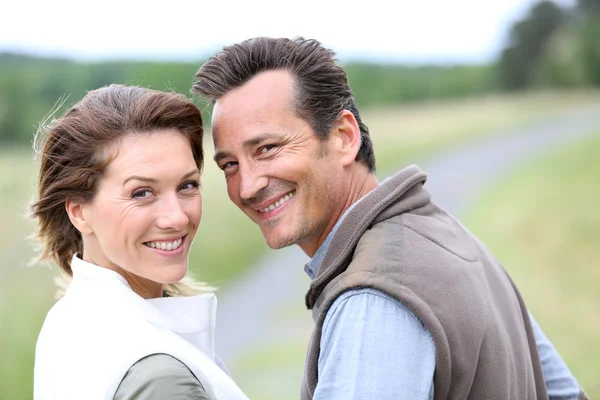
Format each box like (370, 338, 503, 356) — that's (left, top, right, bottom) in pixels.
(302, 167, 548, 400)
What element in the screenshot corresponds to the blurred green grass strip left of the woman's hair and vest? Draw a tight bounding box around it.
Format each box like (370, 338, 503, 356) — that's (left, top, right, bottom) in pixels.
(0, 149, 55, 399)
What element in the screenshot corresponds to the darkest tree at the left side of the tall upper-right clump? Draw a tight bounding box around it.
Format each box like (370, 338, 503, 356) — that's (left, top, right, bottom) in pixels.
(499, 1, 566, 90)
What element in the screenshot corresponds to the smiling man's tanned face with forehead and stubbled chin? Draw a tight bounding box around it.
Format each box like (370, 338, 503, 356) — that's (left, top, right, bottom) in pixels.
(212, 70, 347, 255)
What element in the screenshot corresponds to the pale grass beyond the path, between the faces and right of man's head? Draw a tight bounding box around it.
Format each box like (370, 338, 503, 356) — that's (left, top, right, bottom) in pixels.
(191, 91, 600, 287)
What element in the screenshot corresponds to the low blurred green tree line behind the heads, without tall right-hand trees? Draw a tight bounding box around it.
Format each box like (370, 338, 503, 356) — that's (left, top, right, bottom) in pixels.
(0, 54, 495, 144)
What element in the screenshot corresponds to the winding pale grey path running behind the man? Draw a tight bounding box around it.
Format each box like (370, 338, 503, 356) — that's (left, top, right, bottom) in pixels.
(216, 105, 600, 363)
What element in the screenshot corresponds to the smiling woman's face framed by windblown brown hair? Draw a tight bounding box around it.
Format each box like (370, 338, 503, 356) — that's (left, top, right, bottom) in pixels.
(81, 130, 202, 295)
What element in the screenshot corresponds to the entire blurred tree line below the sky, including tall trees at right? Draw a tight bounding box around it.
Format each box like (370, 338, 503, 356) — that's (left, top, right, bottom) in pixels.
(0, 0, 600, 146)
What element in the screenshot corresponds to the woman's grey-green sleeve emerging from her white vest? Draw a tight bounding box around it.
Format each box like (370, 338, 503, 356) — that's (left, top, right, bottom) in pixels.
(113, 354, 210, 400)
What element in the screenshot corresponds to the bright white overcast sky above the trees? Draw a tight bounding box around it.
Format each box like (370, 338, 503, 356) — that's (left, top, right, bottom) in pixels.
(0, 0, 569, 63)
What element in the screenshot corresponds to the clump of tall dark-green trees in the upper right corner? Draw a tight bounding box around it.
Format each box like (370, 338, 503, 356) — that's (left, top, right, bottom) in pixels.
(498, 0, 600, 90)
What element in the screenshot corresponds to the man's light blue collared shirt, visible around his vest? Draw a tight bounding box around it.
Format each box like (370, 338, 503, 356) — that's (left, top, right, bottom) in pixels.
(304, 203, 580, 400)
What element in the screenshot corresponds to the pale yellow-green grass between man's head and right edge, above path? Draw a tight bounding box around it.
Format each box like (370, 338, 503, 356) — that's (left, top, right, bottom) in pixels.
(370, 91, 600, 169)
